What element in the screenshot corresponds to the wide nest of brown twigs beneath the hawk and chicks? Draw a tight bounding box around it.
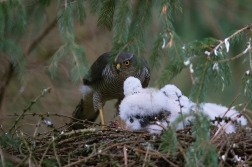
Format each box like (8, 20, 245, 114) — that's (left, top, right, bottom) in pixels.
(0, 113, 252, 167)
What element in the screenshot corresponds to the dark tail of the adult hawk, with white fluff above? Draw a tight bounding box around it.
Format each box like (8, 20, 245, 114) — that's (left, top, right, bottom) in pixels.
(72, 85, 99, 130)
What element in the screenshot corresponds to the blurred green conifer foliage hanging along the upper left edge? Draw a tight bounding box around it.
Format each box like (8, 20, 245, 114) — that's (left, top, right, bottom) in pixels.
(0, 0, 27, 78)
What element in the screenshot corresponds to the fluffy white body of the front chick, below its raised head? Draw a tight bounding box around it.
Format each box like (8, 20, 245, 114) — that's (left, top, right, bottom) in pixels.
(119, 91, 170, 133)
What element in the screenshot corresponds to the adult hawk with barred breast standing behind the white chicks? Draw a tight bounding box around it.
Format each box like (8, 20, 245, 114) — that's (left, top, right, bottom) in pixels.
(73, 52, 150, 129)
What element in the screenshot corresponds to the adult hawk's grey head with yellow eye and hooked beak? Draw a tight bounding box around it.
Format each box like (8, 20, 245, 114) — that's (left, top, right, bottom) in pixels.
(114, 52, 134, 73)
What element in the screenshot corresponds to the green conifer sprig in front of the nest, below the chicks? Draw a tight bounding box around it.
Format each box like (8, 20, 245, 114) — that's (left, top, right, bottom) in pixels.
(161, 112, 218, 166)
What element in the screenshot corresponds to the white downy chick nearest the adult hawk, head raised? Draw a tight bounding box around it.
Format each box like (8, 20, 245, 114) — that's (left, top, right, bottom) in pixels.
(119, 77, 170, 133)
